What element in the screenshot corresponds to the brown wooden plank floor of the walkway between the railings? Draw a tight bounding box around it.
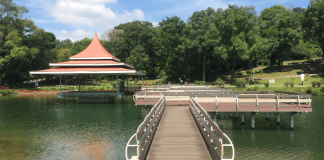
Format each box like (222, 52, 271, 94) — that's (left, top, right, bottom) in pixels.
(146, 106, 212, 160)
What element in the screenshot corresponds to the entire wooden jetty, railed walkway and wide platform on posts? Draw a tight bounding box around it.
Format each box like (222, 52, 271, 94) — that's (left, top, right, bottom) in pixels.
(125, 85, 312, 160)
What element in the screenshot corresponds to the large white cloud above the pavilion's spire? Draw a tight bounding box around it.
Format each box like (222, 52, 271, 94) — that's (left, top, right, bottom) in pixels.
(49, 0, 145, 28)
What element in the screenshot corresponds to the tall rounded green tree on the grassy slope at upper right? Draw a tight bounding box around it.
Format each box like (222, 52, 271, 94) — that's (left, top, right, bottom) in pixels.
(259, 5, 302, 70)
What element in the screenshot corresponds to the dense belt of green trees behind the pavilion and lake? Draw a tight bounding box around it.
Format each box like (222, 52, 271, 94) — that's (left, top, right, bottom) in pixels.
(0, 0, 324, 85)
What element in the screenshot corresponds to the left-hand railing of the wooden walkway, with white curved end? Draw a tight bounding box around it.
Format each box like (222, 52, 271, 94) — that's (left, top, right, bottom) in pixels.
(125, 96, 166, 160)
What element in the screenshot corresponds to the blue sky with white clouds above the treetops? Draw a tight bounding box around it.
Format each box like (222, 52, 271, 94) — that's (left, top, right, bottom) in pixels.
(13, 0, 309, 41)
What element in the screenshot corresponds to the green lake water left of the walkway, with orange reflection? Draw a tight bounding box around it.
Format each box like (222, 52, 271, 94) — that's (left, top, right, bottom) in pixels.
(0, 94, 145, 159)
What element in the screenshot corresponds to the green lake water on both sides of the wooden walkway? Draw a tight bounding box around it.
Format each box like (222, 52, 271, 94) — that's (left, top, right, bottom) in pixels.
(0, 95, 324, 160)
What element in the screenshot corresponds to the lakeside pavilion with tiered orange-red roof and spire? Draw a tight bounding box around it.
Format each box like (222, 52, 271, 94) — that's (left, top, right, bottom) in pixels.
(30, 32, 145, 94)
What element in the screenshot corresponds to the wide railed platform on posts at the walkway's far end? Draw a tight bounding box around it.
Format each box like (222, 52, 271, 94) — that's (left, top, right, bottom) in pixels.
(133, 85, 312, 129)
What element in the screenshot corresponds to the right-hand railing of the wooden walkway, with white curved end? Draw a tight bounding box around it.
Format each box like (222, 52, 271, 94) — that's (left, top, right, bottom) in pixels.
(189, 97, 235, 160)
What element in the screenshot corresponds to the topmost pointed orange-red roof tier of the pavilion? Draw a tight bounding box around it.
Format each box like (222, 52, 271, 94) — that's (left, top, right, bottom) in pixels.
(70, 32, 119, 61)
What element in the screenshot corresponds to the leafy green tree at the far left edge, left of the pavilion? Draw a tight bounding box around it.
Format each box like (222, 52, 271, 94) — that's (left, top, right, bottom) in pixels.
(0, 0, 39, 85)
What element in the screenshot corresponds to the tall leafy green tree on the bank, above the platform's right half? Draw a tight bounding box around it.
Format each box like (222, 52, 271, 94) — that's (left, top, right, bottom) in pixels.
(209, 5, 256, 82)
